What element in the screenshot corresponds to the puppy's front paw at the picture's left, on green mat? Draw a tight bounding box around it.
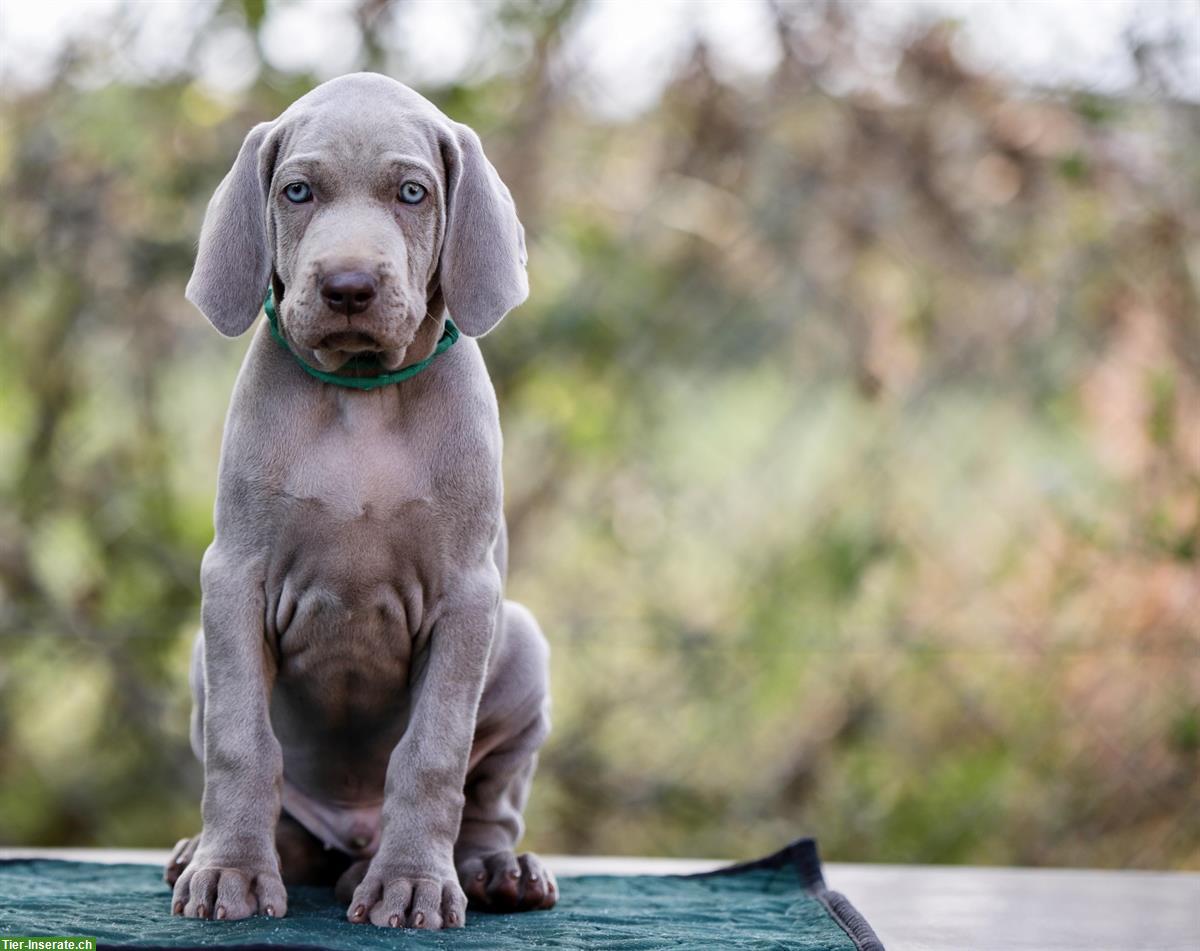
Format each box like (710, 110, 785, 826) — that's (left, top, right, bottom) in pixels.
(170, 856, 288, 921)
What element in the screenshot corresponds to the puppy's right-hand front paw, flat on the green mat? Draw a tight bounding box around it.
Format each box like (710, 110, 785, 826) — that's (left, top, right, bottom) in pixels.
(347, 856, 467, 931)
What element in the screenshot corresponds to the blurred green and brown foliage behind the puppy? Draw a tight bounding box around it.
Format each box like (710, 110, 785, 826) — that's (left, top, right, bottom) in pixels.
(0, 1, 1200, 868)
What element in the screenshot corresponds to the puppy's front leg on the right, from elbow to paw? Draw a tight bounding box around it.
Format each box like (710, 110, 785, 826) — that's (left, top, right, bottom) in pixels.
(347, 564, 500, 929)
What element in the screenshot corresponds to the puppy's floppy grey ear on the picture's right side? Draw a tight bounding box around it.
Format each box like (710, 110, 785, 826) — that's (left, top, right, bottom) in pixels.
(440, 122, 529, 336)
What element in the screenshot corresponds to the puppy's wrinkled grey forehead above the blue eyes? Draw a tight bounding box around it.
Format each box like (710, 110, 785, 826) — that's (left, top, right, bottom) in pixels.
(275, 77, 450, 179)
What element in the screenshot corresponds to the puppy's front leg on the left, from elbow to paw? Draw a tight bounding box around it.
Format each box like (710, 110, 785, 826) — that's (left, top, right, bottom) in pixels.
(172, 548, 288, 919)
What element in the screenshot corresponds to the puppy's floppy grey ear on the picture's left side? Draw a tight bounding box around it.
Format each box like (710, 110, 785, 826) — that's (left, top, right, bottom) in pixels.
(185, 122, 275, 336)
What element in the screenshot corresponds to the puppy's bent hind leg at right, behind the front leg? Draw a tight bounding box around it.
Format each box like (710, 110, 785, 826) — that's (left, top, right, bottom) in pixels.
(455, 602, 558, 911)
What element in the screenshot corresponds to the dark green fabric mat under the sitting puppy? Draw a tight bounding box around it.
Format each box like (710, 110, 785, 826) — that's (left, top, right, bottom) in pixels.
(0, 839, 882, 951)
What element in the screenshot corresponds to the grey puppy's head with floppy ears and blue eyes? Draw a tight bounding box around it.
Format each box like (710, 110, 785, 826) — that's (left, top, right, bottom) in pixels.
(187, 73, 528, 371)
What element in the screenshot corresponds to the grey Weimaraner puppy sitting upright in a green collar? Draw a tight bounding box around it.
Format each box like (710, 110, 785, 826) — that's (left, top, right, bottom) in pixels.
(167, 73, 557, 928)
